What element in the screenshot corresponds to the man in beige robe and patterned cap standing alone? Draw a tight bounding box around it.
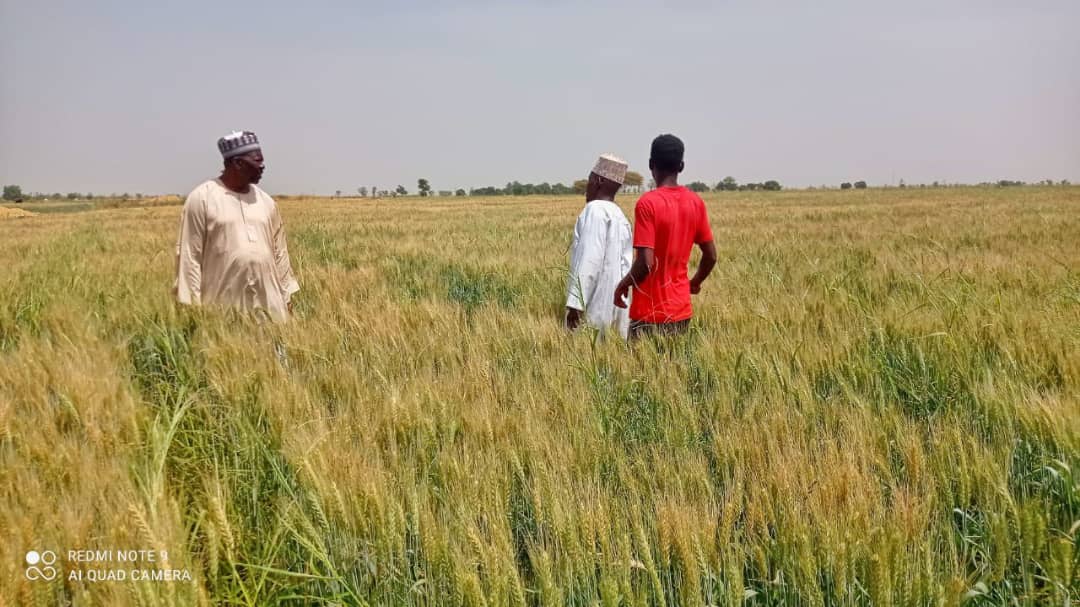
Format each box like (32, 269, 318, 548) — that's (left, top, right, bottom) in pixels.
(175, 131, 300, 321)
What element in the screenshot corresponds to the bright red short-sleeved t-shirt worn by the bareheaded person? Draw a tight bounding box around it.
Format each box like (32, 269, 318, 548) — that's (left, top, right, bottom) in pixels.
(630, 186, 713, 323)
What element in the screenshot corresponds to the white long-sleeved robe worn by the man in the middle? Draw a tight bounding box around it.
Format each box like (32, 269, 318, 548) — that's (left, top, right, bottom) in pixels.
(566, 200, 633, 337)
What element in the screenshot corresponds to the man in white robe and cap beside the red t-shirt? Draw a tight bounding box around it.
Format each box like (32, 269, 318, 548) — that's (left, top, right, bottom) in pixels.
(566, 154, 633, 338)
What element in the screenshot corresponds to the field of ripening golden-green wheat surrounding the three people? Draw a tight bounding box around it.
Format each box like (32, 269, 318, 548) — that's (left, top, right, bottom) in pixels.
(0, 187, 1080, 607)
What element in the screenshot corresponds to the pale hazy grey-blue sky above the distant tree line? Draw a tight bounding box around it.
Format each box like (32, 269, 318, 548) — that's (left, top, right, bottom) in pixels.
(0, 0, 1080, 193)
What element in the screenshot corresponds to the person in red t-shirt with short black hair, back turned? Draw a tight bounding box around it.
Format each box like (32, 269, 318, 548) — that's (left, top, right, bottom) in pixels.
(615, 135, 716, 339)
